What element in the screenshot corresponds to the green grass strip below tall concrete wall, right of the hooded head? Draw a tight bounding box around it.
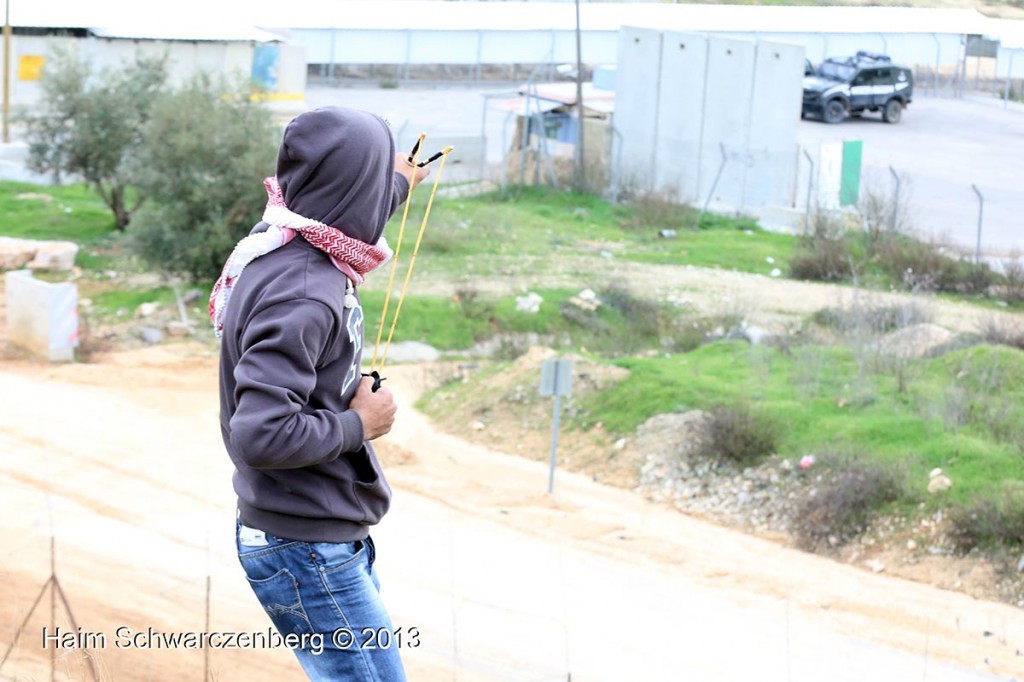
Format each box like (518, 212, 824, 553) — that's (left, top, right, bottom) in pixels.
(387, 186, 797, 274)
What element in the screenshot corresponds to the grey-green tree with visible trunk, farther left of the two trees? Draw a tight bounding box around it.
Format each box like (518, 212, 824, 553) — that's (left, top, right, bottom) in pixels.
(22, 50, 168, 230)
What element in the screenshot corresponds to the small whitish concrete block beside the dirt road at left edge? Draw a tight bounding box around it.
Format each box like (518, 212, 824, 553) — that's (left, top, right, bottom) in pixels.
(4, 270, 78, 363)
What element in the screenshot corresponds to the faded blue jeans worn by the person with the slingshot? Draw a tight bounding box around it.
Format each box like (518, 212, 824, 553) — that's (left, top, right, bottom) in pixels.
(236, 522, 406, 682)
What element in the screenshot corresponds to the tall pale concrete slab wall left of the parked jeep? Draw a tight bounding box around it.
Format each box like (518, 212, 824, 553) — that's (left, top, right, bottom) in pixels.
(614, 28, 804, 212)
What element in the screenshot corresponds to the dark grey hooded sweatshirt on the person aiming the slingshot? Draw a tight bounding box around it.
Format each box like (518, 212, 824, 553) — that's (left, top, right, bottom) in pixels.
(220, 106, 409, 542)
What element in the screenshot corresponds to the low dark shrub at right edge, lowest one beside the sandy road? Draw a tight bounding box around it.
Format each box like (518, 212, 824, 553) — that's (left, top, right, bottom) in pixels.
(949, 486, 1024, 551)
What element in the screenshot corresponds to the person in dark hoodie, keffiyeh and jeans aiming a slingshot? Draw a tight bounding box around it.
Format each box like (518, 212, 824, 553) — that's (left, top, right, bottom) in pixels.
(210, 106, 427, 681)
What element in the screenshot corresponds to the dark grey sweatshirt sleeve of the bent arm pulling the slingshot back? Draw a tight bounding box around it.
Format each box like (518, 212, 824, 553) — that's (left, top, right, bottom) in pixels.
(229, 299, 364, 469)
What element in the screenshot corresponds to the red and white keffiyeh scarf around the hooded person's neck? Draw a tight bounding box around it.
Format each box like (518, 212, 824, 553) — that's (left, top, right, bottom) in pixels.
(210, 177, 392, 339)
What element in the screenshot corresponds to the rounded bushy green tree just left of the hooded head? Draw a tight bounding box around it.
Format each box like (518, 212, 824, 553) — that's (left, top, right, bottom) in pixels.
(129, 74, 279, 280)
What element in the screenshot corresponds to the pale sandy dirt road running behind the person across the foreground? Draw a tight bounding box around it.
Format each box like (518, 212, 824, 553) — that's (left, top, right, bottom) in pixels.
(0, 345, 1024, 682)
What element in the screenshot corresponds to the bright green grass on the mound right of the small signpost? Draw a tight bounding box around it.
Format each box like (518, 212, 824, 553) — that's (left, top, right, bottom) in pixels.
(572, 342, 1024, 503)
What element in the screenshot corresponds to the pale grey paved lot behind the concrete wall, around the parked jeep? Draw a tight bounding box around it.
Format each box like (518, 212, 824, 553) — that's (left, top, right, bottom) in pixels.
(0, 85, 1024, 254)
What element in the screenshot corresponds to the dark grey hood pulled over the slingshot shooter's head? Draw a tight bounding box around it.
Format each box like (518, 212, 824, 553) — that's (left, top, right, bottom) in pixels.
(278, 106, 404, 244)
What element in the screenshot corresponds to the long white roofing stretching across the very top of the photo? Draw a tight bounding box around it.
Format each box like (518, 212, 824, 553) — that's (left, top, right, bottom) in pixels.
(9, 0, 1024, 44)
